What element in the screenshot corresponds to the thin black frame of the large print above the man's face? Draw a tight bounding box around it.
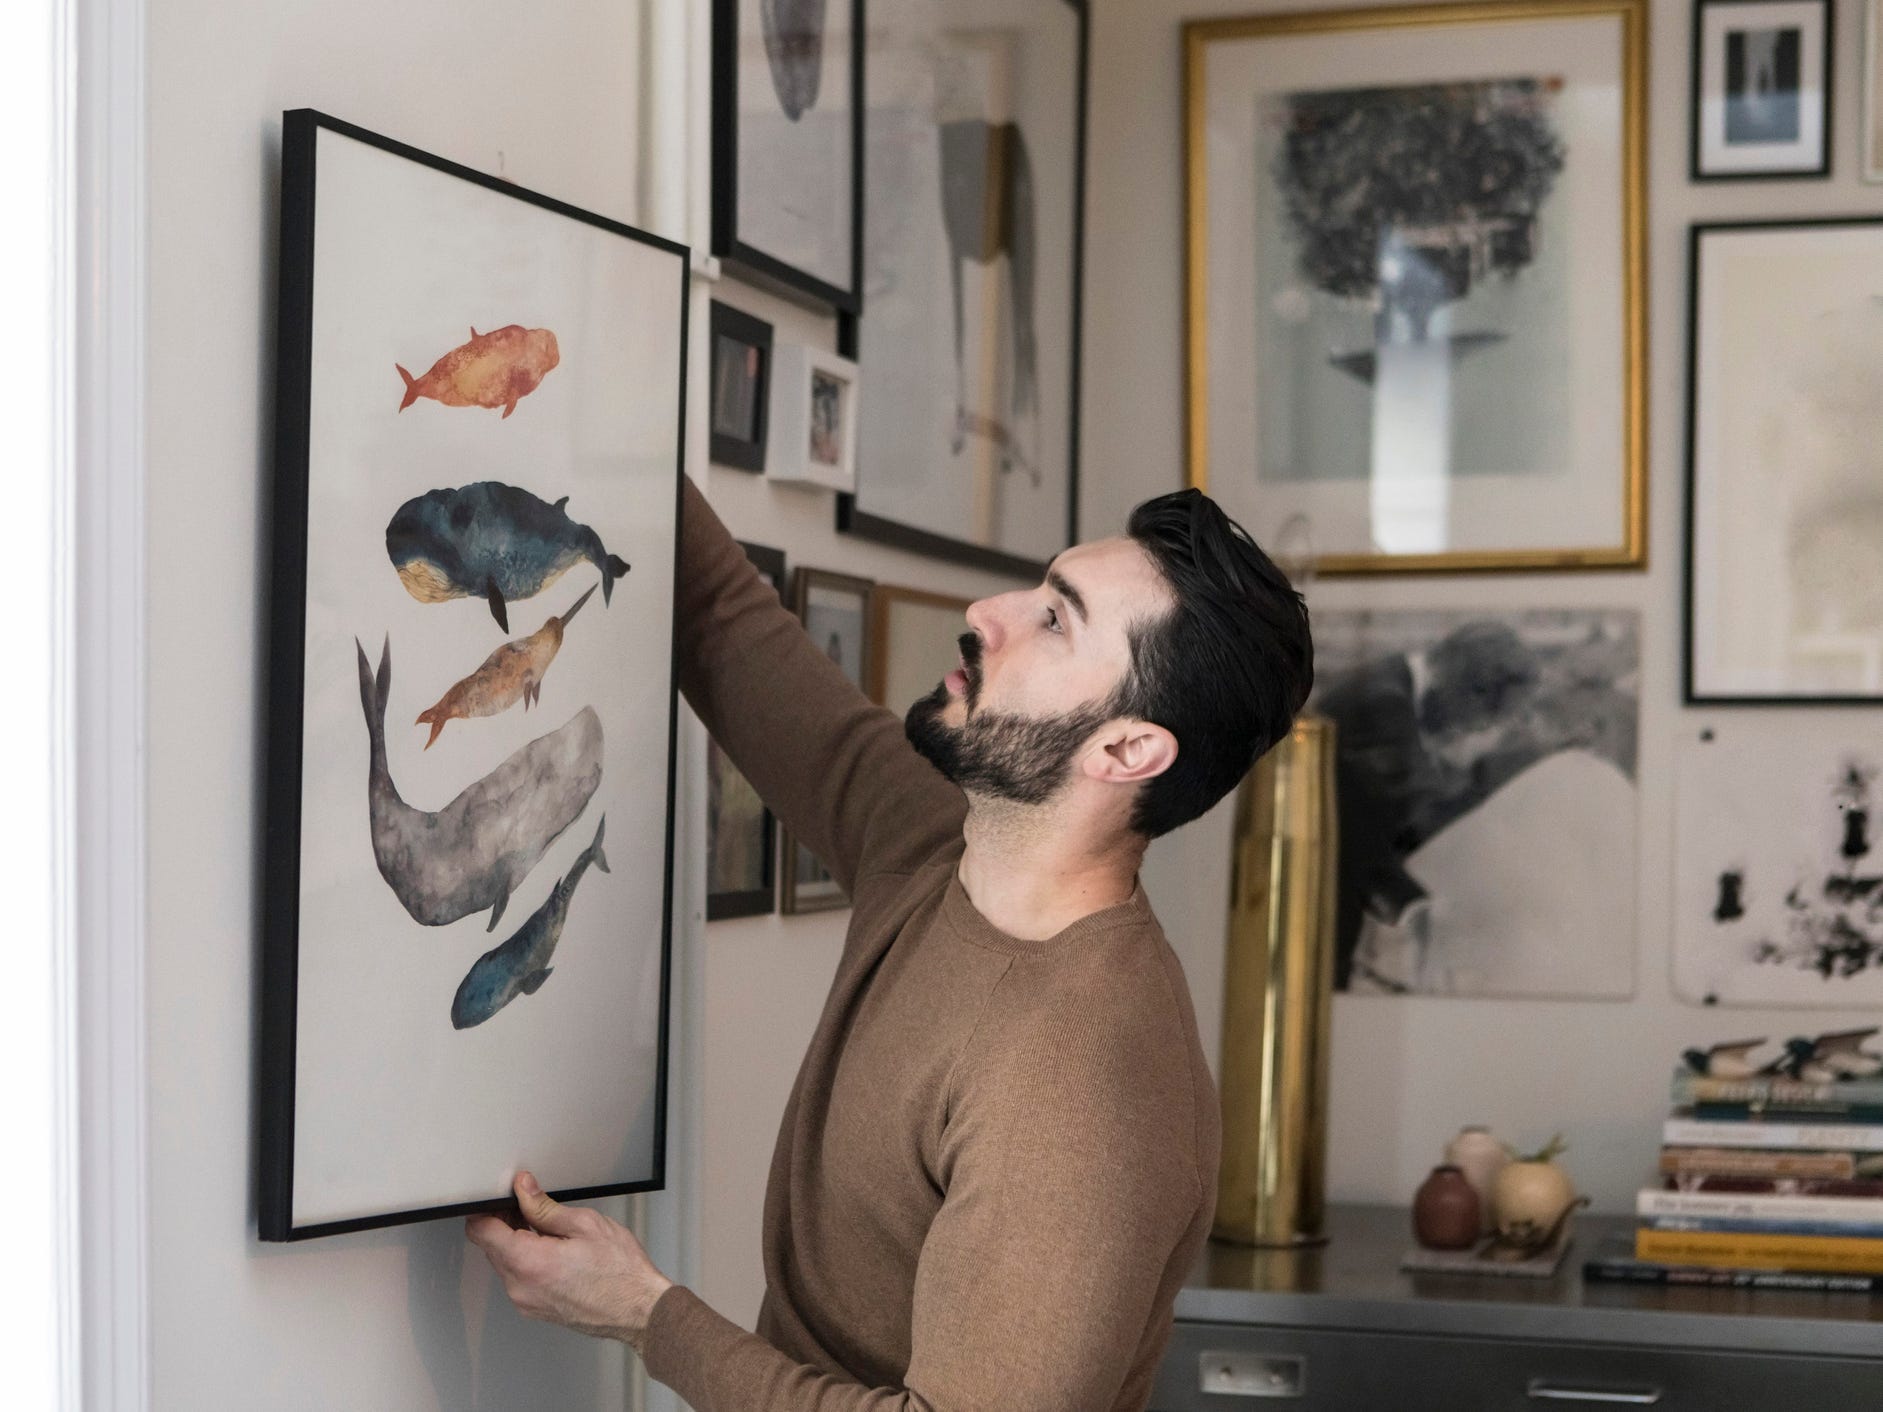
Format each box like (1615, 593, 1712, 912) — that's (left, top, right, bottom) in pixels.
(836, 0, 1092, 580)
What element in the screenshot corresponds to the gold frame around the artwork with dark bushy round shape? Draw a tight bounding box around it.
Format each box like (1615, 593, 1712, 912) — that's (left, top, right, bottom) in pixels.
(1183, 0, 1648, 574)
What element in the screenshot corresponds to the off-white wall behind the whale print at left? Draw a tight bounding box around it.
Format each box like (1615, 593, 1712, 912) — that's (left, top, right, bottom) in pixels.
(149, 0, 640, 1412)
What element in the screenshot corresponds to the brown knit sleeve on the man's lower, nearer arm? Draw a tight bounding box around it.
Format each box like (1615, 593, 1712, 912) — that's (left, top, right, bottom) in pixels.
(646, 963, 1203, 1412)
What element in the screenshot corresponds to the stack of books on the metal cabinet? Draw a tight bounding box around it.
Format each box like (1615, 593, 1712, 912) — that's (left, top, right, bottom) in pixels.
(1584, 1054, 1883, 1292)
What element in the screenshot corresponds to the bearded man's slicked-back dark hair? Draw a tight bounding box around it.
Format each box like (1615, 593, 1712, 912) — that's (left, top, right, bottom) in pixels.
(1113, 489, 1314, 838)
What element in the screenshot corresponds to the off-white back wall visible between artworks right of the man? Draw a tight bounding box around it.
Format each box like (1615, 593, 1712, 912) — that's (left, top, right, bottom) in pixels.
(1085, 0, 1883, 1209)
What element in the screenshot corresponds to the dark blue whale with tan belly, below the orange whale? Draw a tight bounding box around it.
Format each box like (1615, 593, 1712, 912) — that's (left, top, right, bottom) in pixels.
(386, 480, 629, 633)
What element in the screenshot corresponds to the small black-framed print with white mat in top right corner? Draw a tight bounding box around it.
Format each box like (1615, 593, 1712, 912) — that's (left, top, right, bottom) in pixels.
(1691, 0, 1832, 181)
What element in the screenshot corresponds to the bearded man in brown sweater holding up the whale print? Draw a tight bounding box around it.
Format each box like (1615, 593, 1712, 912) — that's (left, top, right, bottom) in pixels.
(467, 486, 1312, 1412)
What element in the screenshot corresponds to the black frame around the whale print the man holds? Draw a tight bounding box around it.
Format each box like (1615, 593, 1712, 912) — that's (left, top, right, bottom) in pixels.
(256, 109, 689, 1243)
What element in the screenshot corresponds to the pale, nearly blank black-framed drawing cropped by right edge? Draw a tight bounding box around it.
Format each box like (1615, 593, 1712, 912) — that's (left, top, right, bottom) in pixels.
(1685, 218, 1883, 706)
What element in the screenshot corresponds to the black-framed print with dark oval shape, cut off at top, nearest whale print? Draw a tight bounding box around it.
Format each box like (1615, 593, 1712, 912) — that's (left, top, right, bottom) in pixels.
(712, 0, 862, 314)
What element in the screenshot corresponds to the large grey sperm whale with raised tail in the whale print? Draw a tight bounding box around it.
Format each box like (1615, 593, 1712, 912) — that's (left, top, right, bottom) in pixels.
(354, 638, 601, 930)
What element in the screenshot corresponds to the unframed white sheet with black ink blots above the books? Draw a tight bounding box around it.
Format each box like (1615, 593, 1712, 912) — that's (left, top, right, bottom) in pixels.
(1674, 714, 1883, 1009)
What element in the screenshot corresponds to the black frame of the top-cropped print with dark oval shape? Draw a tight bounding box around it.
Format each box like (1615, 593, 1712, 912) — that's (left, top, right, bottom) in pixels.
(712, 0, 864, 314)
